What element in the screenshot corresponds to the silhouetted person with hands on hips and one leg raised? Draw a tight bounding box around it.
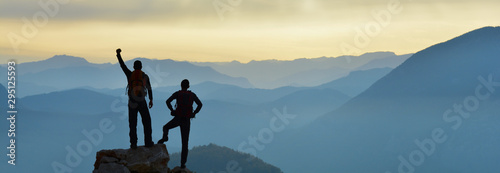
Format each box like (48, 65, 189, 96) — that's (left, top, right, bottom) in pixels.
(158, 79, 203, 168)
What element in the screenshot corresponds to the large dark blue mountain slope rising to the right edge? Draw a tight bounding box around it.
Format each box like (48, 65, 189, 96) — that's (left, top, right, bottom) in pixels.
(259, 27, 500, 172)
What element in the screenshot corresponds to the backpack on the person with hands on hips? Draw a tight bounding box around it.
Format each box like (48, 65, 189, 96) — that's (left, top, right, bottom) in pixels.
(175, 90, 194, 118)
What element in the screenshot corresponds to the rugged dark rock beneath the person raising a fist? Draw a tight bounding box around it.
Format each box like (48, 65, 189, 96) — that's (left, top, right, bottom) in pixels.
(93, 144, 170, 173)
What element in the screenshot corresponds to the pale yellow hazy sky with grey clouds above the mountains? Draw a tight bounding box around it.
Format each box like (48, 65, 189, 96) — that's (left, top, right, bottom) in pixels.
(0, 0, 500, 64)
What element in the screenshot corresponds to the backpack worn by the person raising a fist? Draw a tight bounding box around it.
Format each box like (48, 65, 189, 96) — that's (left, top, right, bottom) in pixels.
(127, 70, 146, 98)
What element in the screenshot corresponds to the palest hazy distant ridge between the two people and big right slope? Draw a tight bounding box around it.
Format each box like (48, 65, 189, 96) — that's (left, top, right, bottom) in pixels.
(195, 52, 411, 89)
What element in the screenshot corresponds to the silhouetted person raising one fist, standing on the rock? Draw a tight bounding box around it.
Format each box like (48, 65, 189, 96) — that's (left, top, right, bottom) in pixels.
(116, 49, 154, 148)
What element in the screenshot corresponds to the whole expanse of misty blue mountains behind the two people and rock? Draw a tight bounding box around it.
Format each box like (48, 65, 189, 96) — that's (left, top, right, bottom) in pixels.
(0, 27, 500, 173)
